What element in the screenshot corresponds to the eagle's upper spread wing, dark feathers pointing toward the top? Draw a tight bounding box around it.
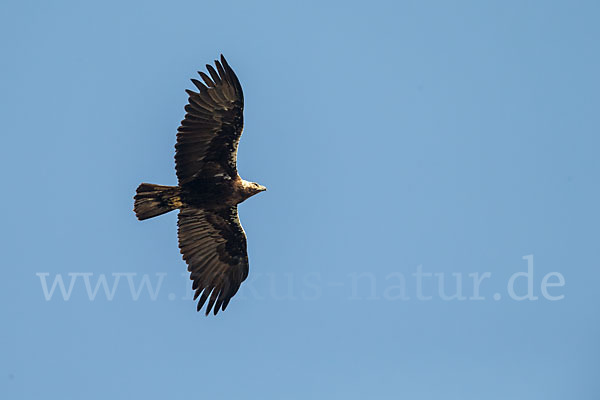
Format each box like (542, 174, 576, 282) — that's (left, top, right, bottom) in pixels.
(175, 55, 244, 185)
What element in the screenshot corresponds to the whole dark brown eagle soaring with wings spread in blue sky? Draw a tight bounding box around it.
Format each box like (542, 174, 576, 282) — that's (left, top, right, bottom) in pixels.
(133, 55, 267, 315)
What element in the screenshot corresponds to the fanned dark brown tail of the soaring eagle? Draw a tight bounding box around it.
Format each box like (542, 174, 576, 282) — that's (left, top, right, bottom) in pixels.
(133, 183, 182, 221)
